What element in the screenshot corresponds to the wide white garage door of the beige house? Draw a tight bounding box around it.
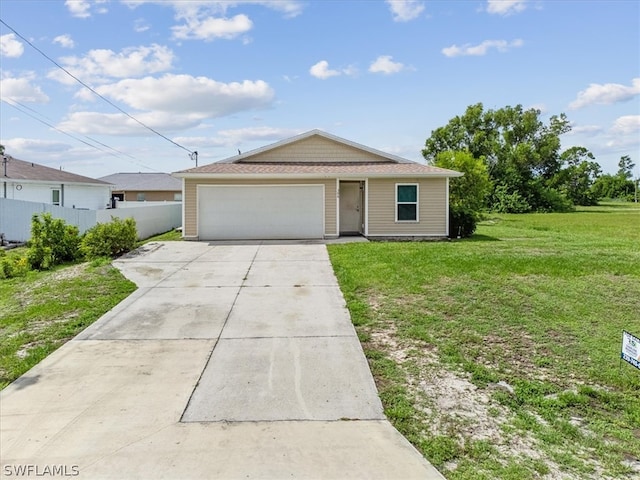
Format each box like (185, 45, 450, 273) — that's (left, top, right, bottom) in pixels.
(198, 185, 324, 240)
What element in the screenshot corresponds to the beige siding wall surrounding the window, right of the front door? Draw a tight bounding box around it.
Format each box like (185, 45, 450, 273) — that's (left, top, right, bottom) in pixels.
(367, 178, 447, 236)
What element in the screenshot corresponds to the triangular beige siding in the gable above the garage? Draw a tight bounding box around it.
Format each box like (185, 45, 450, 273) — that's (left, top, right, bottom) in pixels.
(240, 137, 389, 163)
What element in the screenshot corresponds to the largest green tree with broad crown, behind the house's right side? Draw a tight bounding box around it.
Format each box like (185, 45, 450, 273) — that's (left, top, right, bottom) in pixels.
(422, 103, 571, 211)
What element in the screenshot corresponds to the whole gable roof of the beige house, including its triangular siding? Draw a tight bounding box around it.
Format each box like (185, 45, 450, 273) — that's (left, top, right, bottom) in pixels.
(174, 130, 462, 178)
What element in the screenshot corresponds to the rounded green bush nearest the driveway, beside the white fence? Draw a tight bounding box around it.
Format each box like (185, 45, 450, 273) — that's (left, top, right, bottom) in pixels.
(80, 217, 138, 259)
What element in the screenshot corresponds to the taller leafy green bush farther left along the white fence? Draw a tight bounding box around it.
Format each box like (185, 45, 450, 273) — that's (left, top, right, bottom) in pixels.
(27, 213, 80, 270)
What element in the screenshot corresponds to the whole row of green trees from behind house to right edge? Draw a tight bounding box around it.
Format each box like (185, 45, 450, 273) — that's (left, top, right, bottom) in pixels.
(422, 103, 638, 222)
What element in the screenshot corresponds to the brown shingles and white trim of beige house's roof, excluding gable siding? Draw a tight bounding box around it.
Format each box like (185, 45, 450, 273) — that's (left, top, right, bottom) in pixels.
(174, 130, 462, 177)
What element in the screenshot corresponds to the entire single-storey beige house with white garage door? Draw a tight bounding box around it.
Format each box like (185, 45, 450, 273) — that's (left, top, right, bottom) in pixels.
(174, 130, 462, 240)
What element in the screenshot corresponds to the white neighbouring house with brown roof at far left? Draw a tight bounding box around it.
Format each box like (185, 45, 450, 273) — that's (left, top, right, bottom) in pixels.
(0, 155, 111, 210)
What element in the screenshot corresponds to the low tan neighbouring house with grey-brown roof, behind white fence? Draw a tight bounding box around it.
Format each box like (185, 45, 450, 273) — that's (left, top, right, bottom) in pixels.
(100, 173, 182, 202)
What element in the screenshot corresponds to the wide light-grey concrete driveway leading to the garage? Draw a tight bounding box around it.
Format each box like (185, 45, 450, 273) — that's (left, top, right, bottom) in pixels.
(0, 242, 443, 479)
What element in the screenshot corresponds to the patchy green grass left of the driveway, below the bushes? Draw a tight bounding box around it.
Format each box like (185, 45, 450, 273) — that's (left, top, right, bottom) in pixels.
(0, 262, 136, 388)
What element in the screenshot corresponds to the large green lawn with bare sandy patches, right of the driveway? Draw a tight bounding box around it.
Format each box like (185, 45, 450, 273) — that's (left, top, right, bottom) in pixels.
(329, 204, 640, 479)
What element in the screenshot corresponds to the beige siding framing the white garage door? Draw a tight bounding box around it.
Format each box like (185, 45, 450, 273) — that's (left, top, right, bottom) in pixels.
(183, 178, 337, 238)
